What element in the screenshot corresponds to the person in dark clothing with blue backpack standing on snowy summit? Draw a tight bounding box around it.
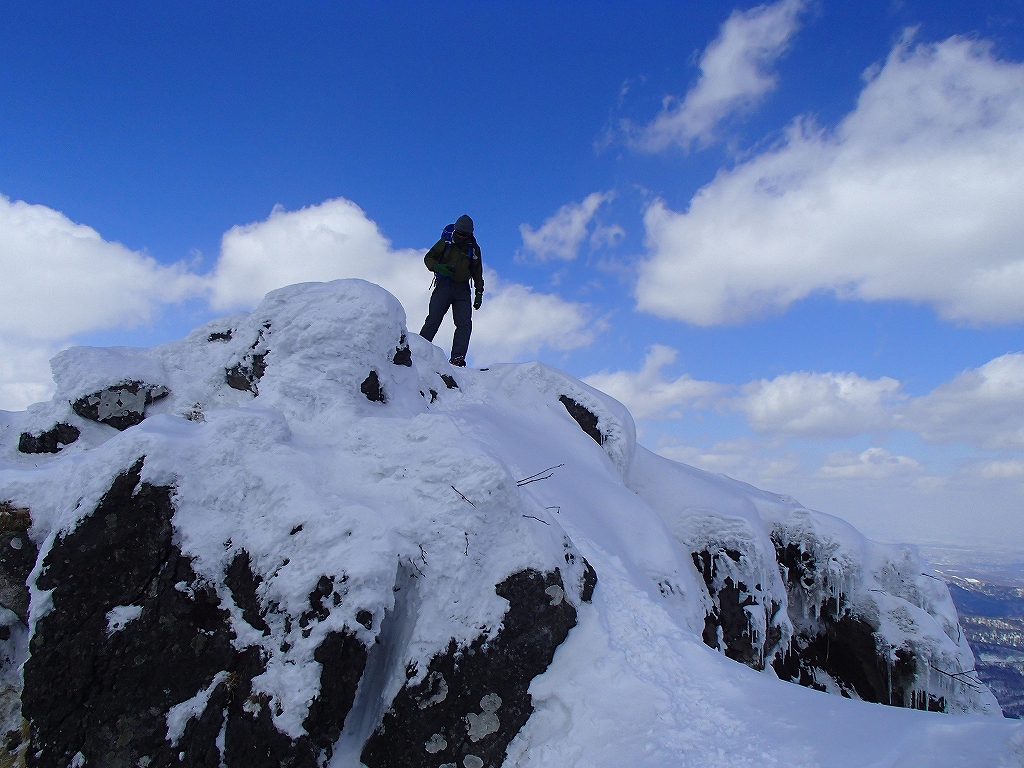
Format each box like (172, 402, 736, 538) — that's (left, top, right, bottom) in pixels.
(420, 214, 483, 368)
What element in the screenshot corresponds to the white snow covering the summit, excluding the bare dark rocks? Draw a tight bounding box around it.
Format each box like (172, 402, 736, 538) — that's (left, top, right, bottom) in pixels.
(0, 281, 1024, 768)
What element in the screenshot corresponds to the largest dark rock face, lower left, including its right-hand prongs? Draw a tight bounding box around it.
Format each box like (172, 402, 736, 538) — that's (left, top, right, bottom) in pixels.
(20, 460, 366, 768)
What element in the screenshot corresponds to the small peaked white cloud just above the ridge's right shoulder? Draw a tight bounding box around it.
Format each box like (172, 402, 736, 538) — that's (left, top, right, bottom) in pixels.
(585, 344, 724, 419)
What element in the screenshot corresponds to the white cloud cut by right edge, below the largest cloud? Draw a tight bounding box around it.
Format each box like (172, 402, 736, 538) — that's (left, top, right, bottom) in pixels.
(897, 352, 1024, 449)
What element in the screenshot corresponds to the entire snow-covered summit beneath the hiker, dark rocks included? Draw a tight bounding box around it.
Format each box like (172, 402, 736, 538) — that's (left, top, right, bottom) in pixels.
(0, 281, 1018, 768)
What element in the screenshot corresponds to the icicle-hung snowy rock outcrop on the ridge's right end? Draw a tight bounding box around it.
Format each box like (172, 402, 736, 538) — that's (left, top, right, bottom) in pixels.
(631, 449, 998, 714)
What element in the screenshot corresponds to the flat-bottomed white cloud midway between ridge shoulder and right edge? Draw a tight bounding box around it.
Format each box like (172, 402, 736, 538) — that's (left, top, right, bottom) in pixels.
(732, 372, 900, 437)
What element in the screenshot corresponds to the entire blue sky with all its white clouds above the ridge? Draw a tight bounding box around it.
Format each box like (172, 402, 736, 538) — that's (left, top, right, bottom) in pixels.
(0, 0, 1024, 548)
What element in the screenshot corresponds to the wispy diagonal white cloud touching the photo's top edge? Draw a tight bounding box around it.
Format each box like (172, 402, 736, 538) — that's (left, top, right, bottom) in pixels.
(633, 0, 804, 152)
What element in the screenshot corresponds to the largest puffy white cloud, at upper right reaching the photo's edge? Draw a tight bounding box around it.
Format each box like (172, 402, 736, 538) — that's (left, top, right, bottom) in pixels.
(636, 38, 1024, 326)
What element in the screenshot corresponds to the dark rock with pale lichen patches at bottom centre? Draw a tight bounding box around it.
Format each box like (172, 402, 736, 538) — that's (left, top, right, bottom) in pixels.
(361, 569, 575, 768)
